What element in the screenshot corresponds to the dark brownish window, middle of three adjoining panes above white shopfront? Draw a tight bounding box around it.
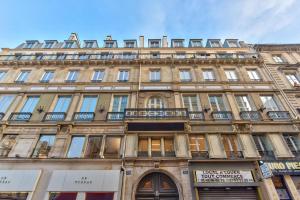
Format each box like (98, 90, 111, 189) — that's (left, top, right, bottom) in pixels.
(84, 136, 102, 158)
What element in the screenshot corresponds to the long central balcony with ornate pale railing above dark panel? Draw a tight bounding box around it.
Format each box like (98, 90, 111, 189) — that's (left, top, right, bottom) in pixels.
(125, 108, 189, 120)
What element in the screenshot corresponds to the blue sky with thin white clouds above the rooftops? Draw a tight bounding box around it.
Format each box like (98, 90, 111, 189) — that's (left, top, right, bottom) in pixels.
(0, 0, 300, 48)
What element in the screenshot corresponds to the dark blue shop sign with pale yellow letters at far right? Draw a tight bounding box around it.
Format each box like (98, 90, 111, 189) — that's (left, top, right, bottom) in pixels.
(264, 161, 300, 175)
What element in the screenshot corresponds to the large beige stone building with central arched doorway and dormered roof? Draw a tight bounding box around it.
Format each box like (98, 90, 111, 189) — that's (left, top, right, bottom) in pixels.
(0, 34, 299, 200)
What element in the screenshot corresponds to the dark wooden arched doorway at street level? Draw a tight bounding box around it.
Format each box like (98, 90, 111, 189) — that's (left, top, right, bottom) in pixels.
(135, 172, 179, 200)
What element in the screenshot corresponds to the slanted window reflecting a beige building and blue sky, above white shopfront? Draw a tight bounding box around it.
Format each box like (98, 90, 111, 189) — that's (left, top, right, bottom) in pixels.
(32, 135, 55, 158)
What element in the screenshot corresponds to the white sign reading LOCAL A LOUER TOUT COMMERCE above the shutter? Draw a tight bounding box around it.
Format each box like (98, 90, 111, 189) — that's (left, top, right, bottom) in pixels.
(196, 170, 254, 183)
